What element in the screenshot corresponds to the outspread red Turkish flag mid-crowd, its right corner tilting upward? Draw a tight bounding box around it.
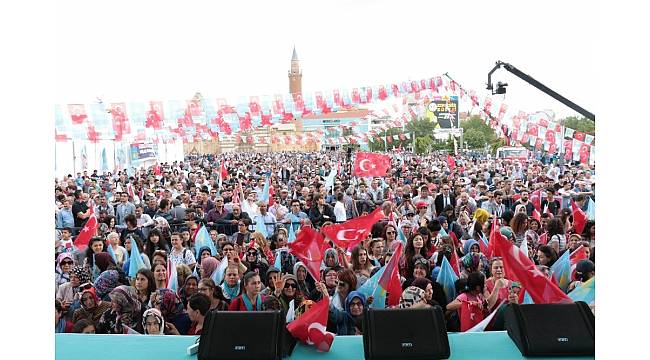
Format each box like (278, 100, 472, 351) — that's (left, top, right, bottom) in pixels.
(320, 208, 384, 249)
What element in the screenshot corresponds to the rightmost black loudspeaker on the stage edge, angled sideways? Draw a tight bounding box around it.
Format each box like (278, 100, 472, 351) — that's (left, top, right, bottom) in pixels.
(505, 301, 595, 356)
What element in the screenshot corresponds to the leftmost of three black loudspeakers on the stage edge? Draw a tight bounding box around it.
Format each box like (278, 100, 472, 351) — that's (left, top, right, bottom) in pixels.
(198, 310, 285, 360)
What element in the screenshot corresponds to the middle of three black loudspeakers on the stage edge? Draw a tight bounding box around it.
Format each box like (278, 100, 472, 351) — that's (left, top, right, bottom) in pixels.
(363, 306, 450, 360)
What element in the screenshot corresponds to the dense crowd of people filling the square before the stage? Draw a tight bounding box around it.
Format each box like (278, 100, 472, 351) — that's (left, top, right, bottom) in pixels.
(55, 151, 595, 335)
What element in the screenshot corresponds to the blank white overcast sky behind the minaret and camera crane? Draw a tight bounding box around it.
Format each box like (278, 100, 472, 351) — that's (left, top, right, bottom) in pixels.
(55, 0, 592, 116)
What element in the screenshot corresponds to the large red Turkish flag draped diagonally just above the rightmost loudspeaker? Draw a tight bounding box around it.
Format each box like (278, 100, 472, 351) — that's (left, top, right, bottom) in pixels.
(490, 228, 573, 304)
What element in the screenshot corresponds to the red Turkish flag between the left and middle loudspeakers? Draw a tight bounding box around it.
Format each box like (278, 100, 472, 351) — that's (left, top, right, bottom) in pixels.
(287, 296, 336, 351)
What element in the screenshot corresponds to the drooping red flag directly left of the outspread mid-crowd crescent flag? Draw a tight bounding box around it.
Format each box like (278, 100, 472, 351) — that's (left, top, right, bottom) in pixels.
(289, 227, 327, 281)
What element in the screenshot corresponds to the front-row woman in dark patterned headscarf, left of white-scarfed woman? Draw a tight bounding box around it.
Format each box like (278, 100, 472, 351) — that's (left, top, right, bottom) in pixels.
(96, 285, 142, 334)
